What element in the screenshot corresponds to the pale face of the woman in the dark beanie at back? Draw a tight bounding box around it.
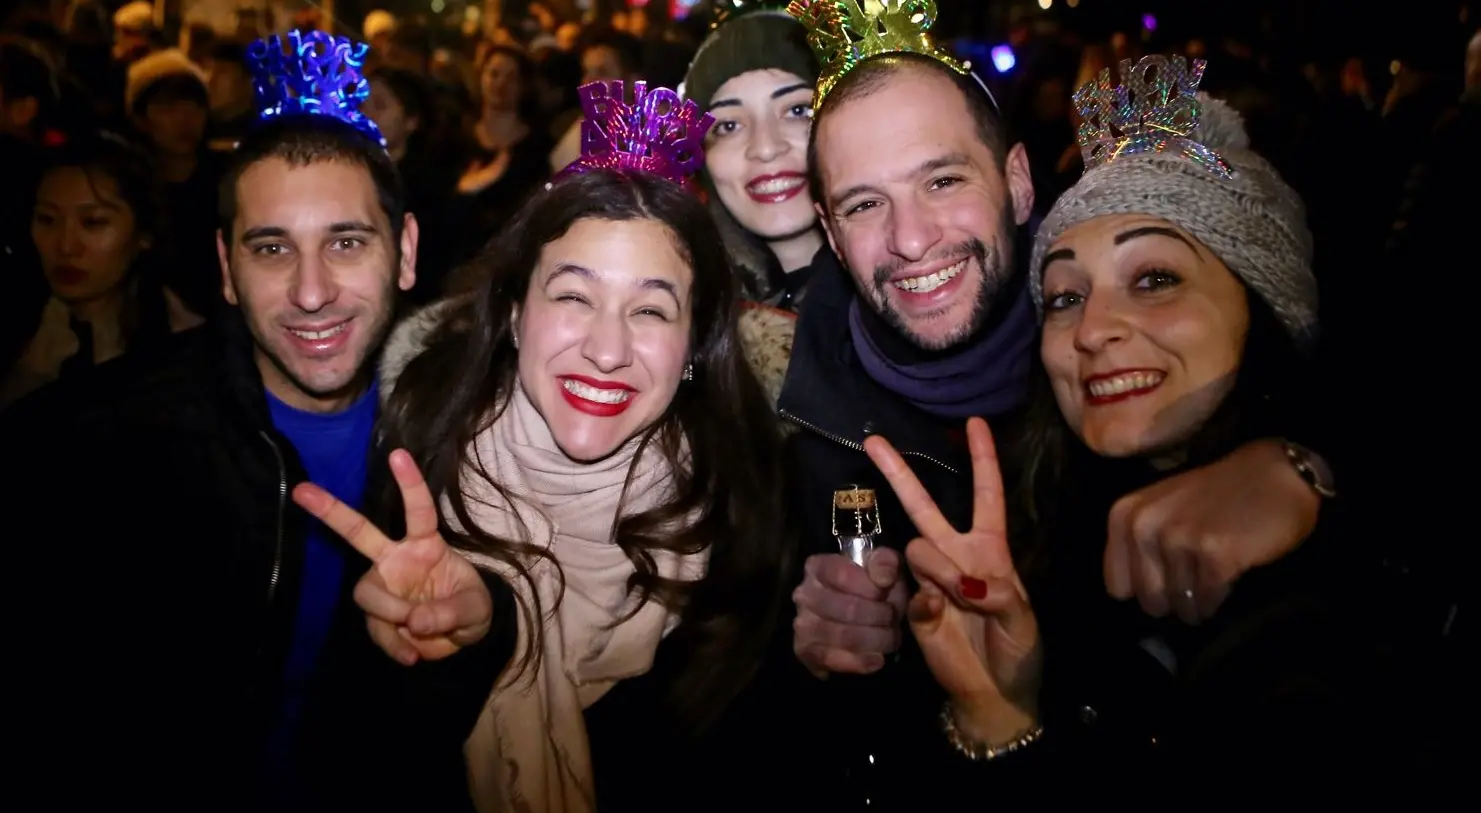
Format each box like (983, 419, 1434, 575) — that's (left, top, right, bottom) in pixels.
(705, 70, 818, 240)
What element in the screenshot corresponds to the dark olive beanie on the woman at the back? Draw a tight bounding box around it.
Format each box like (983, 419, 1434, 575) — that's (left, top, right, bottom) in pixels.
(678, 9, 818, 110)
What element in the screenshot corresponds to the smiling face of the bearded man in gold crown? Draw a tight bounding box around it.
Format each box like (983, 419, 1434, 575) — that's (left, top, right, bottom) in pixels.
(816, 65, 1034, 349)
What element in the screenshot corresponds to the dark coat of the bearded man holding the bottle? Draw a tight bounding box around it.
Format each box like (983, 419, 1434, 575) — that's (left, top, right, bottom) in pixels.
(778, 249, 1017, 810)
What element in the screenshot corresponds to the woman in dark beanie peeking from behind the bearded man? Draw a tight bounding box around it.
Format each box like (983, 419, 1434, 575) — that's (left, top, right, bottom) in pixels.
(680, 0, 823, 310)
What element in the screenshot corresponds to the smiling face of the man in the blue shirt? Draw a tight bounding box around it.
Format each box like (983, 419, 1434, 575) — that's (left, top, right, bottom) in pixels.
(216, 158, 416, 412)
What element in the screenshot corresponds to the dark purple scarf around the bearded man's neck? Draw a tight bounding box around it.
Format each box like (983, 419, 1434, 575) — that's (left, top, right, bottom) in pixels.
(849, 286, 1038, 421)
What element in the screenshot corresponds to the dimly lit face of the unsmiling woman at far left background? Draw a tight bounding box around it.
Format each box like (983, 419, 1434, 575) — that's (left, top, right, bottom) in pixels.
(31, 167, 148, 304)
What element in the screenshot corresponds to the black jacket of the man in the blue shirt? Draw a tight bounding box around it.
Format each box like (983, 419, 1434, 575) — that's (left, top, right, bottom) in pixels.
(4, 320, 514, 810)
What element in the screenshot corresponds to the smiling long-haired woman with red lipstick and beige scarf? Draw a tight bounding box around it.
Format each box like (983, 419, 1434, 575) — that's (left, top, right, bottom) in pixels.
(368, 87, 791, 813)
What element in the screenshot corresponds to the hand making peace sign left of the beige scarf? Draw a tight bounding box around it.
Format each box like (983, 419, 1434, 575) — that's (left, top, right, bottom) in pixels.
(293, 449, 493, 666)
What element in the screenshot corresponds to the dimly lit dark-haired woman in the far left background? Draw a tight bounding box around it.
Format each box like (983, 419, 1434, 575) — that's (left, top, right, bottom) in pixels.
(0, 135, 200, 409)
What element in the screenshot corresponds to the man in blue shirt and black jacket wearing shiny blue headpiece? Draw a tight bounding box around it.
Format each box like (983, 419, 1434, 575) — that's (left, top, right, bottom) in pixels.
(3, 31, 515, 812)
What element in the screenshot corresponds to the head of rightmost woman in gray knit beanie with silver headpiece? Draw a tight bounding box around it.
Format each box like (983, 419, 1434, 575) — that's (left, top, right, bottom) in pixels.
(1029, 56, 1317, 462)
